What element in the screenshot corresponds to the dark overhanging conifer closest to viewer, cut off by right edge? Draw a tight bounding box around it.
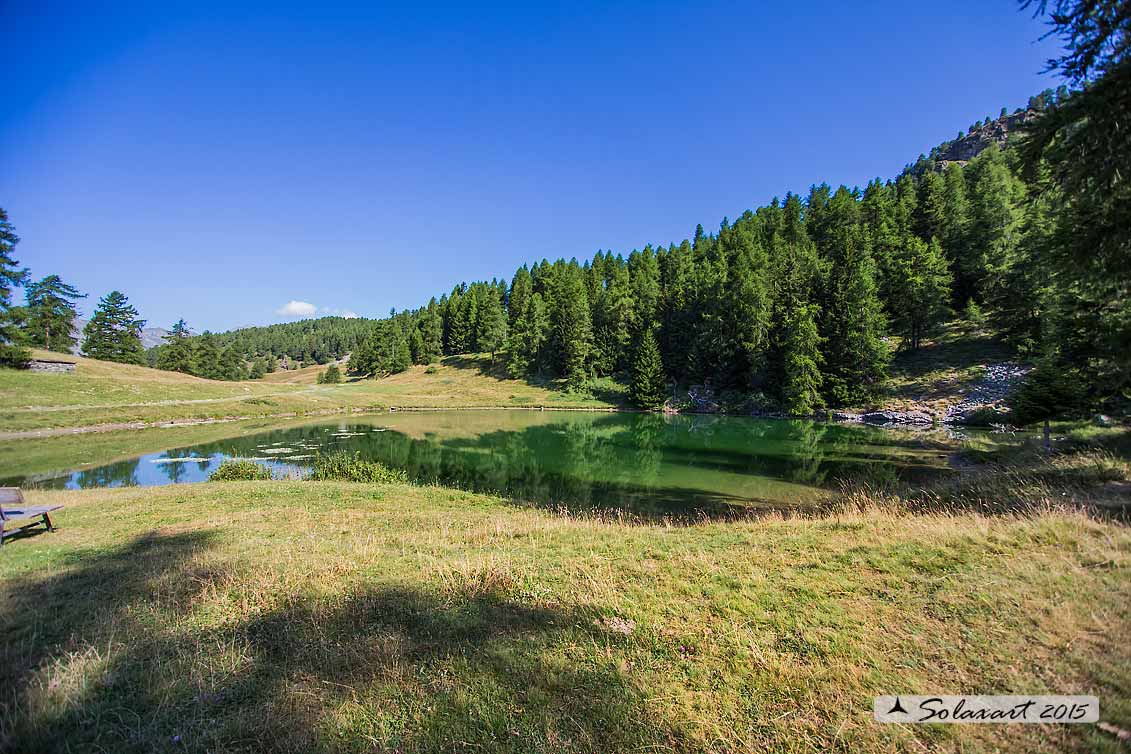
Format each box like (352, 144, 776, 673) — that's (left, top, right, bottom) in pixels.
(1021, 0, 1131, 402)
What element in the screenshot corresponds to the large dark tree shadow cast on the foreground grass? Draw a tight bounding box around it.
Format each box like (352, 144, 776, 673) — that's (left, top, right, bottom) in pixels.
(0, 534, 679, 753)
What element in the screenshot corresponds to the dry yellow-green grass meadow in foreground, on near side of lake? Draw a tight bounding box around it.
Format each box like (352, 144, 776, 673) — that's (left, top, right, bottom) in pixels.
(0, 482, 1131, 752)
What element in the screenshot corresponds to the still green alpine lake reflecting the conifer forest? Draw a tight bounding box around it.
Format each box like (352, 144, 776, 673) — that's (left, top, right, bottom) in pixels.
(0, 410, 995, 515)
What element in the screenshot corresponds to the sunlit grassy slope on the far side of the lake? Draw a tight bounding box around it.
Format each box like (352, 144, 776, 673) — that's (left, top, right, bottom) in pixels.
(0, 352, 623, 432)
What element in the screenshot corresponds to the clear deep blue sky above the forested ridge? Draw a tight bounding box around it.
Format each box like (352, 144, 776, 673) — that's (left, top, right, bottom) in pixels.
(0, 0, 1056, 330)
